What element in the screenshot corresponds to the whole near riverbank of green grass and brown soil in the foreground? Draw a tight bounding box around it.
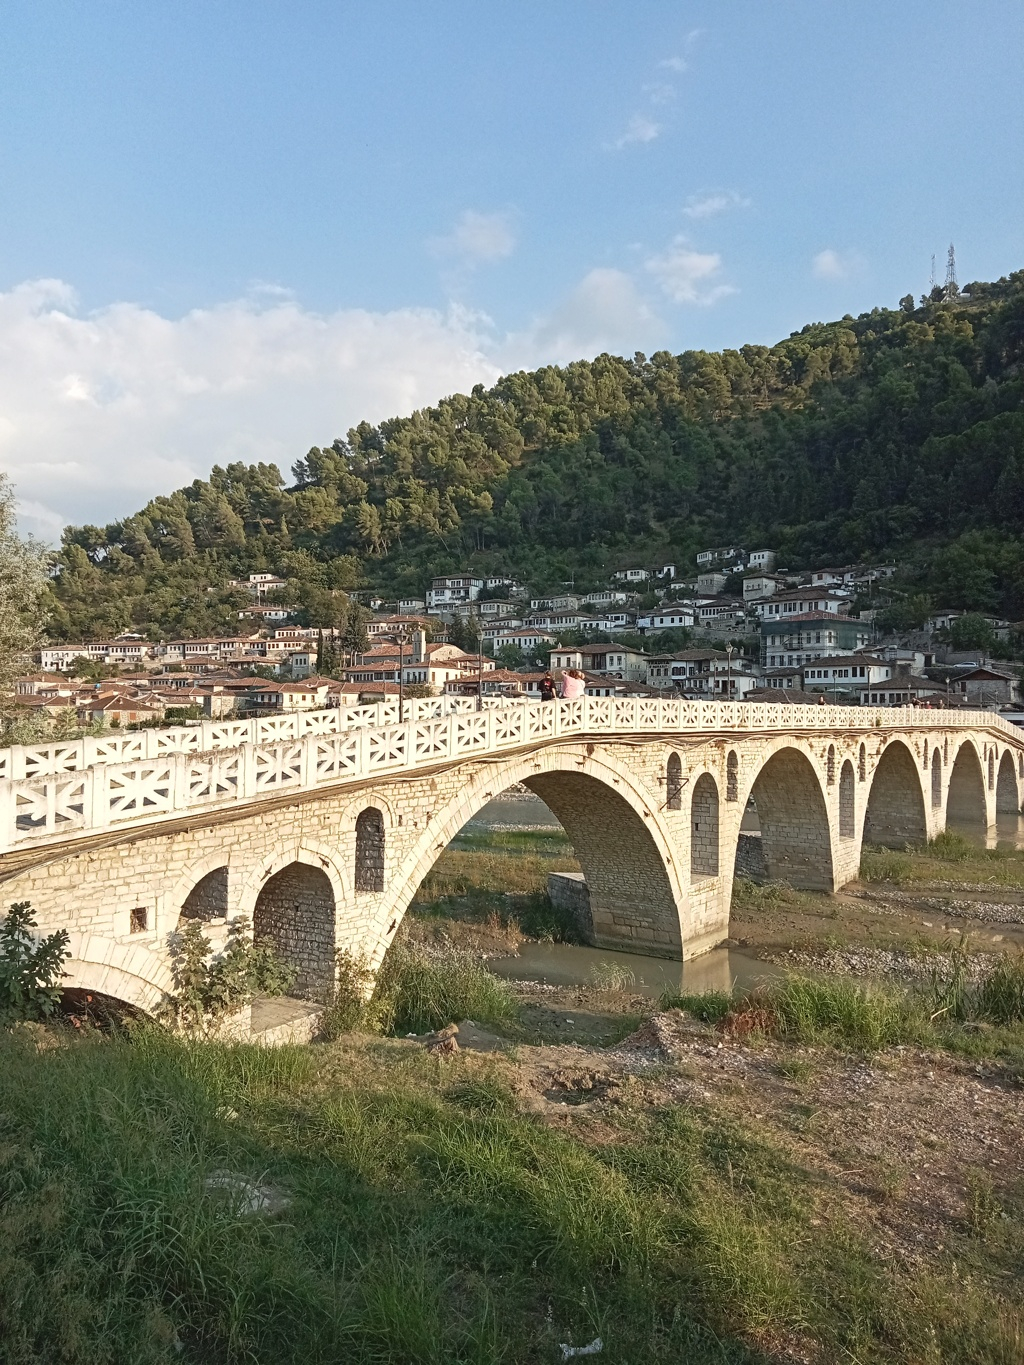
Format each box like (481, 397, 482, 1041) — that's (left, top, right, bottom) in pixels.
(0, 996, 1024, 1365)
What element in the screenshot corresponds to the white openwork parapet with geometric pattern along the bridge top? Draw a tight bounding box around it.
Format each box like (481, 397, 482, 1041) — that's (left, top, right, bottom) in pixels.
(0, 698, 1024, 854)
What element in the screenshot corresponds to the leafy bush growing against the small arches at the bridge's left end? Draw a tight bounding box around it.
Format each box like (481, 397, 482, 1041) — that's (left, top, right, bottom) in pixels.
(164, 916, 295, 1032)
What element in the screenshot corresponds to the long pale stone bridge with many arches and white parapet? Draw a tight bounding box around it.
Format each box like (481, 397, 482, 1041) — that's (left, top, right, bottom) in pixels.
(0, 698, 1024, 1009)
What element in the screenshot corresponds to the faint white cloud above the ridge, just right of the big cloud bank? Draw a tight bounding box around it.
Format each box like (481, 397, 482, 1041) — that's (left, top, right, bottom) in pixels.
(513, 268, 665, 367)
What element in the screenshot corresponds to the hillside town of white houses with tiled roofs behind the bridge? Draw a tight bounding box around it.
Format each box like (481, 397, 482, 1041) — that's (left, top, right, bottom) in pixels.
(15, 545, 1024, 730)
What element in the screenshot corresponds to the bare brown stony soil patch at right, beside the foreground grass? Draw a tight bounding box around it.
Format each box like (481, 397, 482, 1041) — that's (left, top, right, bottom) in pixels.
(453, 1010, 1024, 1265)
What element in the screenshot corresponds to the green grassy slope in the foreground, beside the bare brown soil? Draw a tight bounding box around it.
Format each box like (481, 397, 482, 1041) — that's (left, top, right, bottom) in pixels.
(0, 1029, 1024, 1365)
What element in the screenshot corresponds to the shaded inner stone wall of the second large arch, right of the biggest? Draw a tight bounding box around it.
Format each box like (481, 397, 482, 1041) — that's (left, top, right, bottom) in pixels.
(750, 745, 836, 891)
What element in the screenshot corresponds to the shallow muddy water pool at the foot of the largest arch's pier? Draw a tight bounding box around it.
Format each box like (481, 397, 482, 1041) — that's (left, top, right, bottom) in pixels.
(487, 942, 784, 998)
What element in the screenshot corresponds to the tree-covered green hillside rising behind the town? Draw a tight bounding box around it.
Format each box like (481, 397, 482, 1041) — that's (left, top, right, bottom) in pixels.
(51, 270, 1024, 639)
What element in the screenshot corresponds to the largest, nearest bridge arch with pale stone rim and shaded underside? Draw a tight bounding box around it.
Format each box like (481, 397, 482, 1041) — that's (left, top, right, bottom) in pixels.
(371, 747, 688, 968)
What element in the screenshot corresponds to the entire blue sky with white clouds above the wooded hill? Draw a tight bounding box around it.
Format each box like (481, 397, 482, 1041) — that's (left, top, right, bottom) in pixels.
(0, 0, 1024, 535)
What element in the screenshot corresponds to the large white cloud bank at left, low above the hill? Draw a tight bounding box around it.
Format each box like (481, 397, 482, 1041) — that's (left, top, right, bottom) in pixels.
(0, 280, 501, 539)
